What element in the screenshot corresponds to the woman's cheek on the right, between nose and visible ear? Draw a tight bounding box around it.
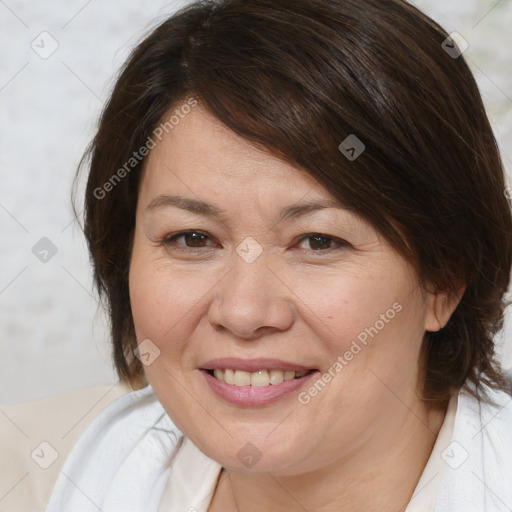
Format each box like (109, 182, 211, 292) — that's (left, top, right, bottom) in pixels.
(296, 262, 425, 381)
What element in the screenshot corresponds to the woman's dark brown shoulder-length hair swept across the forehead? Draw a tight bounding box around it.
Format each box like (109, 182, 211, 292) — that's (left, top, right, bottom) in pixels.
(78, 0, 512, 402)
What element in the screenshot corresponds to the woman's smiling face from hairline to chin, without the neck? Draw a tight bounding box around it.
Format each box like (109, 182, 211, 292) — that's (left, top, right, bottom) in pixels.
(129, 105, 446, 475)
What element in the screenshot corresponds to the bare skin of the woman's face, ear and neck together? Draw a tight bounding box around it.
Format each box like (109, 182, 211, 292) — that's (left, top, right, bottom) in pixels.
(129, 105, 464, 512)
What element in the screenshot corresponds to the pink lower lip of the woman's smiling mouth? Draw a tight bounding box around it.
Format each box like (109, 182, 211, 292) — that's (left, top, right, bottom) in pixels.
(201, 370, 319, 407)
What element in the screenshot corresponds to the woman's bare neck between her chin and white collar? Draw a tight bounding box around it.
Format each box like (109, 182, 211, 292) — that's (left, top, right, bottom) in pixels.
(208, 404, 446, 512)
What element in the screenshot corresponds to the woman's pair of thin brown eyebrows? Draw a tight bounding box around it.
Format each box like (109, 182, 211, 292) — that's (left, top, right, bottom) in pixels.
(145, 195, 343, 223)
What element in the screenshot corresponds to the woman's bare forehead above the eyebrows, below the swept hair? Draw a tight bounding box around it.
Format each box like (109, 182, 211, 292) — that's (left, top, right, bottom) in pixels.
(141, 105, 324, 199)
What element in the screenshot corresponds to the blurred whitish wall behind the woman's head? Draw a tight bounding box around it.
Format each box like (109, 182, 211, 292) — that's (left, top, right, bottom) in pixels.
(0, 0, 512, 404)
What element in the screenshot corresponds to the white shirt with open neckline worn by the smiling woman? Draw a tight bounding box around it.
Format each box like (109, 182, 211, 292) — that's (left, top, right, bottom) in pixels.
(46, 386, 512, 512)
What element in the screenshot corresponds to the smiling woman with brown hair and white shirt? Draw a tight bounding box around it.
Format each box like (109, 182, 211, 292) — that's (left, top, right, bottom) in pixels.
(2, 0, 512, 512)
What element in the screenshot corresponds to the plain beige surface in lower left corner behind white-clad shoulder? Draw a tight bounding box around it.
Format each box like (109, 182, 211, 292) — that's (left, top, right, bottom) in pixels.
(0, 382, 136, 512)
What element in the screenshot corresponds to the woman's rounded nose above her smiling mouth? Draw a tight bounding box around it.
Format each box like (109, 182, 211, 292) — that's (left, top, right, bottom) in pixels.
(208, 250, 295, 341)
